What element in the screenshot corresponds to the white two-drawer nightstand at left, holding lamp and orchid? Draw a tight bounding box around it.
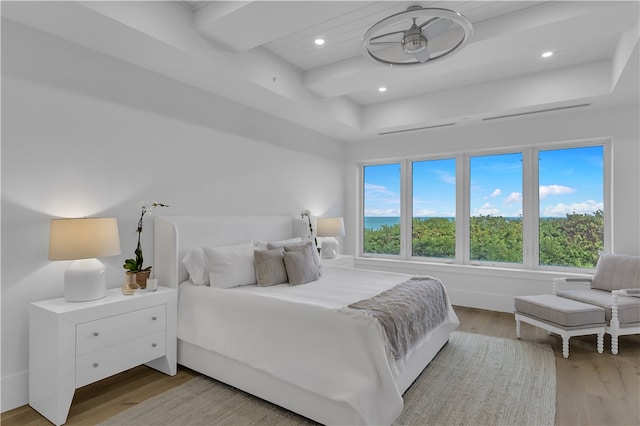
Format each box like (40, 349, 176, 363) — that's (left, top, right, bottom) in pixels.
(29, 287, 178, 425)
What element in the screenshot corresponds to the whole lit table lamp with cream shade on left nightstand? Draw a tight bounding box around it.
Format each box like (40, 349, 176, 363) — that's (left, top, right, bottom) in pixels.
(49, 218, 120, 302)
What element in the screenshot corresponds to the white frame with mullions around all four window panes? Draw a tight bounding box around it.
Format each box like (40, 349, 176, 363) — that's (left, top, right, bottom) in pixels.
(356, 138, 613, 273)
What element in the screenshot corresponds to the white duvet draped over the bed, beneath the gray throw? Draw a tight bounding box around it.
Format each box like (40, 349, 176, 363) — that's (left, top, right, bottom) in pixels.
(178, 266, 459, 424)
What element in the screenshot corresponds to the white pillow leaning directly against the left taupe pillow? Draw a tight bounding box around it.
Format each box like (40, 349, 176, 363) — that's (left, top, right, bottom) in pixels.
(203, 243, 258, 288)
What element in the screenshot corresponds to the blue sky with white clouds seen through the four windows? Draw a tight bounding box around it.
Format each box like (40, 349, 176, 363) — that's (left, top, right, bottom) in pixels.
(365, 146, 603, 217)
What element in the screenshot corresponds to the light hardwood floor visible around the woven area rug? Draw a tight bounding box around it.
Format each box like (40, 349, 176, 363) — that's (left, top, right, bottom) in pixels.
(0, 307, 640, 426)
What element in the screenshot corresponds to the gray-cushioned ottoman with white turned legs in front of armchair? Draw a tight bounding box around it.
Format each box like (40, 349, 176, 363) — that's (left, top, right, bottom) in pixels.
(515, 294, 606, 358)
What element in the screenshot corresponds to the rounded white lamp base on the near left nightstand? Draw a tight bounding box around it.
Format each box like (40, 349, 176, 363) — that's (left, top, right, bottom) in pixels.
(64, 259, 107, 302)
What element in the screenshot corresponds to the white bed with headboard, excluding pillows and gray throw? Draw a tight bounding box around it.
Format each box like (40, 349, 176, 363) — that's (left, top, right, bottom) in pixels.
(154, 216, 459, 425)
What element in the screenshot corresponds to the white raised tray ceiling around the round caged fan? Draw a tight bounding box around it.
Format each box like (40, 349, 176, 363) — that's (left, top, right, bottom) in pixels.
(2, 1, 639, 141)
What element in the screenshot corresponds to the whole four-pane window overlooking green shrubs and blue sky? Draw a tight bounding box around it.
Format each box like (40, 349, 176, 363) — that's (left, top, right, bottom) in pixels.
(360, 142, 611, 272)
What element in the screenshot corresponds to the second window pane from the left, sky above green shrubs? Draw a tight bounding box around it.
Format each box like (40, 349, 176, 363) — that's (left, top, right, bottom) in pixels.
(411, 158, 456, 259)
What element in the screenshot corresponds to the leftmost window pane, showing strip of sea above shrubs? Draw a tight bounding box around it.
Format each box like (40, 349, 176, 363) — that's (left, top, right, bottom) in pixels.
(362, 163, 401, 255)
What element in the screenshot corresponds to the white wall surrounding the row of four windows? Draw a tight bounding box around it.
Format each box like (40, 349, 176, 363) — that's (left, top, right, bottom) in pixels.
(345, 105, 640, 312)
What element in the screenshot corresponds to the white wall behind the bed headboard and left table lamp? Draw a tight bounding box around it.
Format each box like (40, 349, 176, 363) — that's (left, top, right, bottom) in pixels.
(1, 20, 345, 411)
